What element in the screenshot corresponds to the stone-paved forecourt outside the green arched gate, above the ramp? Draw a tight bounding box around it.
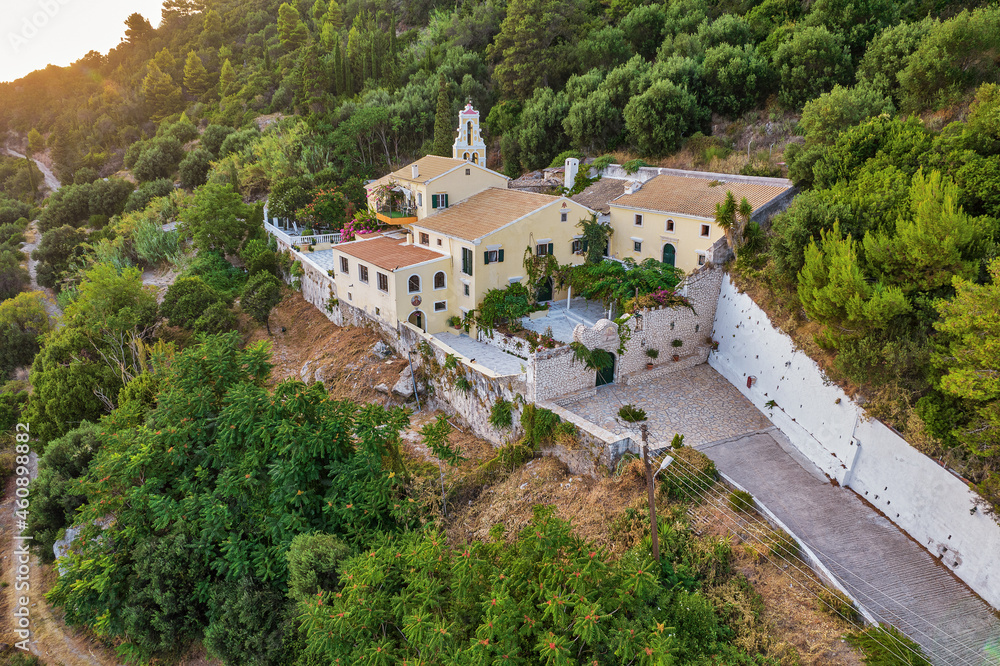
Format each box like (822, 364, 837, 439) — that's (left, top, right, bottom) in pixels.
(556, 363, 771, 446)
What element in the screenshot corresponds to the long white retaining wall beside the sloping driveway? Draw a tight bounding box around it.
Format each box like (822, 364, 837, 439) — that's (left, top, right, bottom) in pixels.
(709, 275, 1000, 608)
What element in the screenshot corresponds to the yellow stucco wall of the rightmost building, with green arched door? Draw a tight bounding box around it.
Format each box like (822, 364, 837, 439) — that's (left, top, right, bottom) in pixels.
(611, 204, 726, 273)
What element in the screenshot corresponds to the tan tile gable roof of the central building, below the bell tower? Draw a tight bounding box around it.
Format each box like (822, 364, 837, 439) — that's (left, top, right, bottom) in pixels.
(413, 187, 562, 241)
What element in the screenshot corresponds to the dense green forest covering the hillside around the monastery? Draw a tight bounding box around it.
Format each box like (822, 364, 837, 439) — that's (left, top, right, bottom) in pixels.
(0, 0, 1000, 665)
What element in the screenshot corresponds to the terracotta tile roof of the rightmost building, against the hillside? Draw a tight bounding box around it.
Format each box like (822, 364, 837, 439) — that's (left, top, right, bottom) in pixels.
(612, 175, 791, 218)
